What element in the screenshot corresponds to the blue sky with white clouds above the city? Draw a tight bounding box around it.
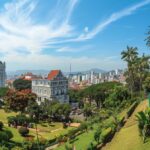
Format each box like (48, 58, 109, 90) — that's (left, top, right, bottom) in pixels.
(0, 0, 150, 71)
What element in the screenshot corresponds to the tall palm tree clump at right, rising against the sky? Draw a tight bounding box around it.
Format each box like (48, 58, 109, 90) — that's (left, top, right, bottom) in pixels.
(121, 47, 150, 93)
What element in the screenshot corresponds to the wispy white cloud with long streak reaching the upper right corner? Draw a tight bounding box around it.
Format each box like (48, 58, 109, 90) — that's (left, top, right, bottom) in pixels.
(0, 0, 150, 53)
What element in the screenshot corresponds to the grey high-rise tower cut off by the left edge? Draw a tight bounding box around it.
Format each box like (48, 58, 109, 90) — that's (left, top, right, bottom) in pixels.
(0, 61, 6, 87)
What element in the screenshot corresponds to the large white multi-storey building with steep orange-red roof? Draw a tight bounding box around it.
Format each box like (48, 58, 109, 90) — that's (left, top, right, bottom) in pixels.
(32, 70, 69, 103)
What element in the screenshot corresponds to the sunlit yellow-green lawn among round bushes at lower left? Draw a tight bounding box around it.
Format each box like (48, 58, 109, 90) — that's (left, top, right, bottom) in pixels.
(0, 109, 72, 142)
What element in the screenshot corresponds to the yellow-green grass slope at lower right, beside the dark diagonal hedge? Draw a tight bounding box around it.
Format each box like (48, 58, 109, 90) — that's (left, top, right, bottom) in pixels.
(102, 101, 150, 150)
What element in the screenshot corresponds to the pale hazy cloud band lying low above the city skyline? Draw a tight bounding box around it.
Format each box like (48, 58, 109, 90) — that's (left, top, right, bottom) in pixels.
(3, 53, 124, 71)
